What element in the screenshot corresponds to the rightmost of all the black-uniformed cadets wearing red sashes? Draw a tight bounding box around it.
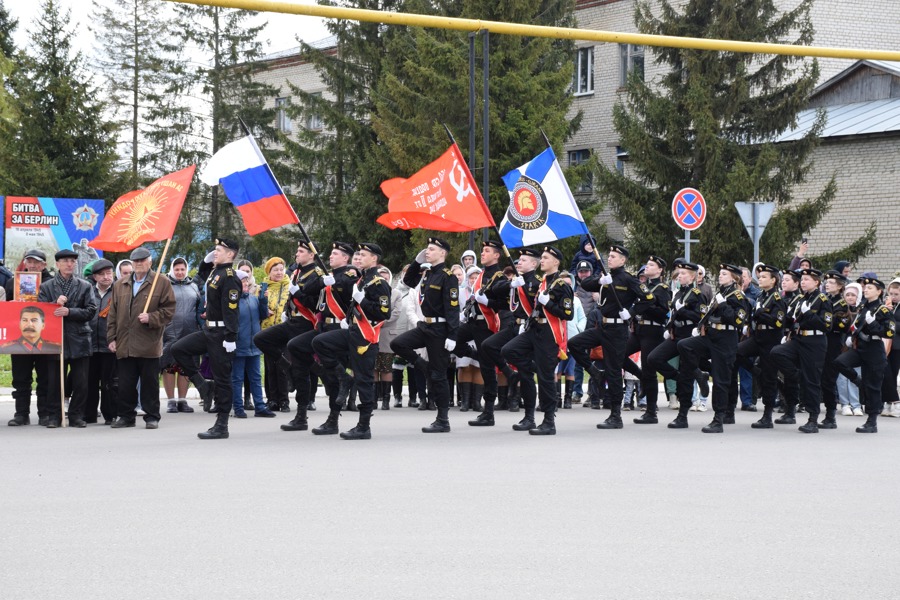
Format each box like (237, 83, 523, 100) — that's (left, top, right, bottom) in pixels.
(502, 246, 574, 435)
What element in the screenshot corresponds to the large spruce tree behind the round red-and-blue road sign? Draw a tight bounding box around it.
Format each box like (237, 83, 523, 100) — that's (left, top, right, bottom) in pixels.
(597, 0, 874, 264)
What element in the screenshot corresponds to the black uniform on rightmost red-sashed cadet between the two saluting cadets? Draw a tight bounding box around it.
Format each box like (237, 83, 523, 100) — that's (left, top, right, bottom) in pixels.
(312, 267, 391, 431)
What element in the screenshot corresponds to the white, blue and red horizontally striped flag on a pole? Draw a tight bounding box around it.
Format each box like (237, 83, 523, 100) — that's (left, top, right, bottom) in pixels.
(200, 135, 300, 235)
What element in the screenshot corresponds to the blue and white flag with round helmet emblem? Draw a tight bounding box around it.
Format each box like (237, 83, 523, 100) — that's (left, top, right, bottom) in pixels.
(500, 148, 588, 248)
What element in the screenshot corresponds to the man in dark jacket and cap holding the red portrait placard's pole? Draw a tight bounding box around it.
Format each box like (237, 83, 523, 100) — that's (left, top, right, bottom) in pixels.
(38, 249, 97, 428)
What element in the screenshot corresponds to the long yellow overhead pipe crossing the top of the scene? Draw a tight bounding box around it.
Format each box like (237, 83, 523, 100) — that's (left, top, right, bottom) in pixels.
(167, 0, 900, 61)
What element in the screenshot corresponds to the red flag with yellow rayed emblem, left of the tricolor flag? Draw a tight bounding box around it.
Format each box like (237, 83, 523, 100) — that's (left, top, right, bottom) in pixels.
(88, 165, 197, 252)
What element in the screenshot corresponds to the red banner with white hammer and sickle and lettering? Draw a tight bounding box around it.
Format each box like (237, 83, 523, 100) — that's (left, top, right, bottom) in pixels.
(377, 143, 495, 231)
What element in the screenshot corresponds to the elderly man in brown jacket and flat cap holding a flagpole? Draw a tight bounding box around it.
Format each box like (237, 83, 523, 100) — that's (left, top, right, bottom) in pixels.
(106, 248, 175, 429)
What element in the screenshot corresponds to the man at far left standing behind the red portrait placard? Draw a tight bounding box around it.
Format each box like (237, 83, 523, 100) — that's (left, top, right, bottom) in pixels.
(5, 248, 53, 427)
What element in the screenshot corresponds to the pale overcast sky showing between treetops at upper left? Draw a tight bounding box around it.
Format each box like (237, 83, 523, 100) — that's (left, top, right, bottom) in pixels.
(3, 0, 328, 58)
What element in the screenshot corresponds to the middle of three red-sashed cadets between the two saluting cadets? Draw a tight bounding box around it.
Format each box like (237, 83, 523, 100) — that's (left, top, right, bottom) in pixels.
(281, 242, 359, 433)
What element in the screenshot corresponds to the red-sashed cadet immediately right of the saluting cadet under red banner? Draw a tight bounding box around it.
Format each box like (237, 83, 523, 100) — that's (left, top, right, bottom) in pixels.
(442, 240, 508, 427)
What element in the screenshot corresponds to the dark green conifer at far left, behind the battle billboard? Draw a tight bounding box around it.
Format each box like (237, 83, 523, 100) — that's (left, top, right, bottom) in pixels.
(0, 0, 116, 198)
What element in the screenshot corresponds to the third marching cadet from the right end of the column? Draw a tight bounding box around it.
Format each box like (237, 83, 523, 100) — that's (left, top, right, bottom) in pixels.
(770, 268, 832, 433)
